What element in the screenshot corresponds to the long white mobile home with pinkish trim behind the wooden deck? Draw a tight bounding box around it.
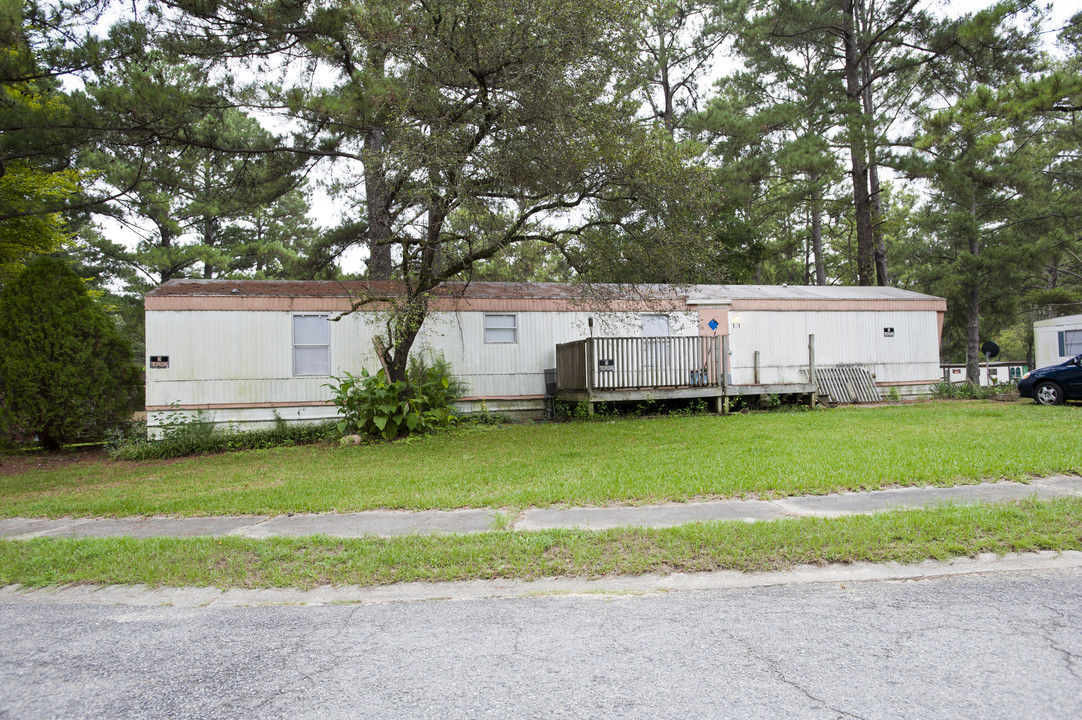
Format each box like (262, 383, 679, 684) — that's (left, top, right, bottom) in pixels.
(146, 279, 946, 432)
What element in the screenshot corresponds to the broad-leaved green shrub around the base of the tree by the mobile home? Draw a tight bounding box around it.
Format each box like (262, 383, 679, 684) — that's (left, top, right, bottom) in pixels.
(327, 358, 463, 440)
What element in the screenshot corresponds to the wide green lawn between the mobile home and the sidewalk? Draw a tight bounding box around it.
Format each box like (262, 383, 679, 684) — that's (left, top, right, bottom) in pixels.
(0, 402, 1082, 516)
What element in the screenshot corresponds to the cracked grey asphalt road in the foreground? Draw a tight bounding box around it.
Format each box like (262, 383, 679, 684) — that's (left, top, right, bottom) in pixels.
(0, 570, 1082, 720)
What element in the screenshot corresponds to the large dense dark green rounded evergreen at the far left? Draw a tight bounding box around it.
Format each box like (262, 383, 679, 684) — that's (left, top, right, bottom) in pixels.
(0, 257, 140, 450)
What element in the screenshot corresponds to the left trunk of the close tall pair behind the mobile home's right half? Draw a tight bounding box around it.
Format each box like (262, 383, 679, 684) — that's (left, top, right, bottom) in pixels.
(842, 0, 875, 285)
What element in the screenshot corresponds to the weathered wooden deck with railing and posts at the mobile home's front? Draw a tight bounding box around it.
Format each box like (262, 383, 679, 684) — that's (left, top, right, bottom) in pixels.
(556, 336, 817, 414)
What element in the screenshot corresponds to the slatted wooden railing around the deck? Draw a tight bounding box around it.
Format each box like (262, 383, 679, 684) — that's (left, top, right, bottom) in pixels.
(556, 337, 722, 391)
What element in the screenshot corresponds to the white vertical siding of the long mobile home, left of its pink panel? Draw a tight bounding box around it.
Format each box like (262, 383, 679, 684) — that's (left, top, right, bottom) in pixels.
(146, 310, 698, 431)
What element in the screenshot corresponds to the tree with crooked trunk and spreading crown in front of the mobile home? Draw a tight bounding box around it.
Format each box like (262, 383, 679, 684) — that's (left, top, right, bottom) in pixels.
(147, 0, 683, 379)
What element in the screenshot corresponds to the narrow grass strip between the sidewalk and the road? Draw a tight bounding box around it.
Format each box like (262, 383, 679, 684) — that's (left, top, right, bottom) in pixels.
(0, 498, 1082, 588)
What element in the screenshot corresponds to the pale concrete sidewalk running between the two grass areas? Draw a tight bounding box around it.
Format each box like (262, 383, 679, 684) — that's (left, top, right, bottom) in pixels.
(0, 475, 1082, 539)
